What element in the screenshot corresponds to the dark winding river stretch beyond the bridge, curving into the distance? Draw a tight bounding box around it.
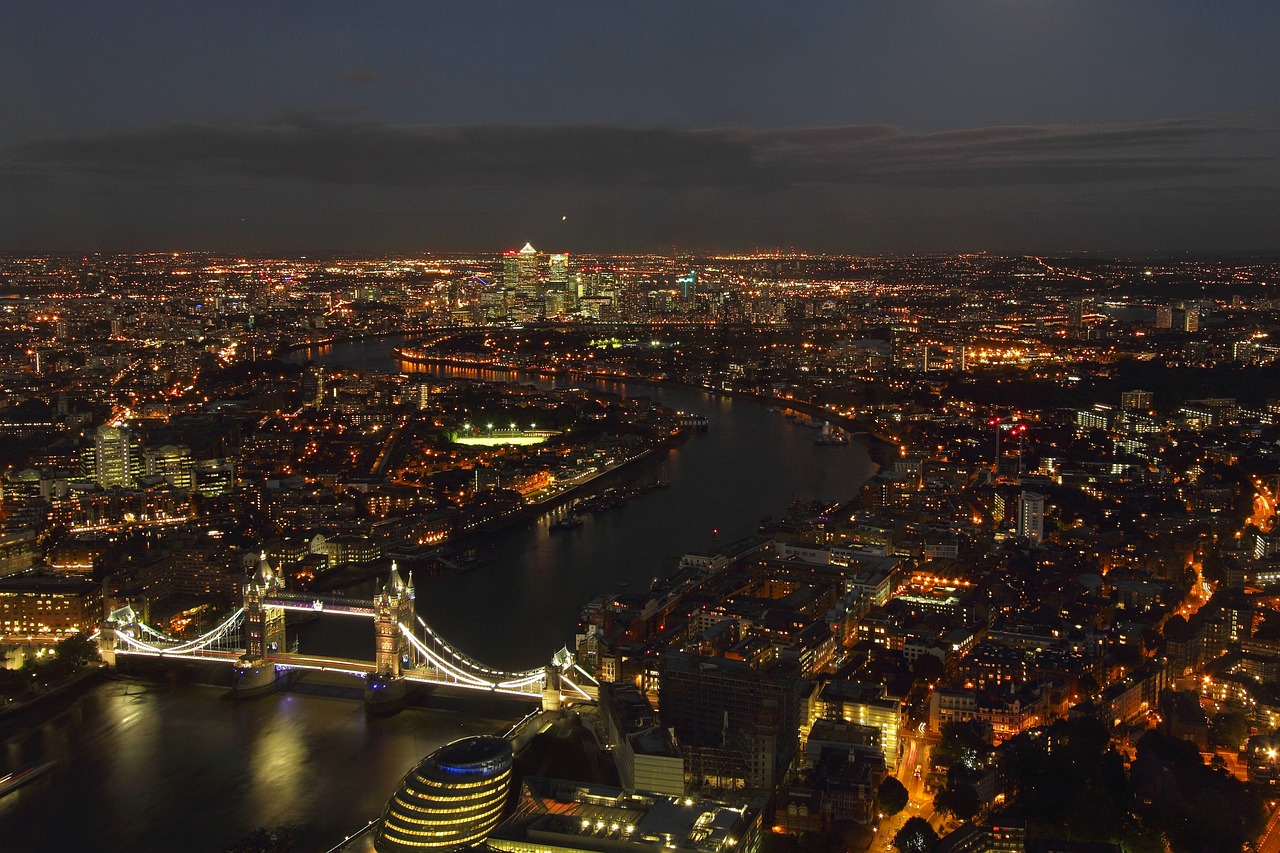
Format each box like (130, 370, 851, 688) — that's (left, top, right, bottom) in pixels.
(289, 338, 876, 670)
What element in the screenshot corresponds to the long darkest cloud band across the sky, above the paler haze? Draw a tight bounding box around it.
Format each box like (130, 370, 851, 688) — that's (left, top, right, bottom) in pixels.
(8, 114, 1274, 188)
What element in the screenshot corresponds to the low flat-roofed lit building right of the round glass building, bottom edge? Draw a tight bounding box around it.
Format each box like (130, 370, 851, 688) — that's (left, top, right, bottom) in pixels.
(486, 776, 758, 853)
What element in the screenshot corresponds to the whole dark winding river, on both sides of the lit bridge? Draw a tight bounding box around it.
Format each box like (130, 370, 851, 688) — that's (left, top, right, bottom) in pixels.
(0, 339, 876, 853)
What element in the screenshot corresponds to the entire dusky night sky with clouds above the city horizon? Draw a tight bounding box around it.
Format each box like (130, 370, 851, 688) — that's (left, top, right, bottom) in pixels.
(0, 0, 1280, 254)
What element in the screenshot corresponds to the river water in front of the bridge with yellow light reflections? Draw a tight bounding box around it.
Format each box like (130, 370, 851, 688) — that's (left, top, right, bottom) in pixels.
(0, 683, 527, 853)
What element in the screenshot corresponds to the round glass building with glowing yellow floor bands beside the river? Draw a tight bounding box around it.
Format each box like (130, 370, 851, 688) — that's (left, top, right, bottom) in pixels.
(374, 736, 512, 853)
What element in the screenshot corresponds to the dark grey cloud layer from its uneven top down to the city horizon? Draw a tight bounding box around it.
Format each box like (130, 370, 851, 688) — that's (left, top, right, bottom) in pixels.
(0, 109, 1280, 251)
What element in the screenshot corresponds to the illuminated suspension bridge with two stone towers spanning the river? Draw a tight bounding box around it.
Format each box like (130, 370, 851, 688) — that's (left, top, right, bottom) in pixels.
(99, 553, 596, 712)
